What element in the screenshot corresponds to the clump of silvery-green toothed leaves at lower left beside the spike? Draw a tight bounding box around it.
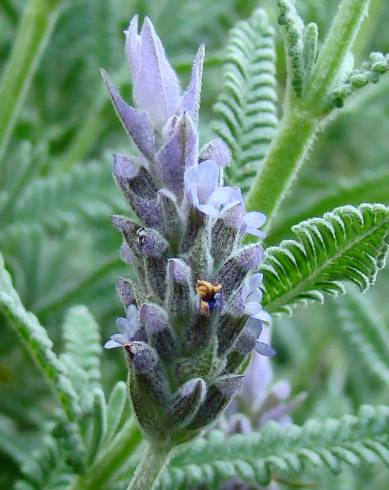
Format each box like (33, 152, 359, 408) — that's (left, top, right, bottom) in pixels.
(0, 253, 136, 488)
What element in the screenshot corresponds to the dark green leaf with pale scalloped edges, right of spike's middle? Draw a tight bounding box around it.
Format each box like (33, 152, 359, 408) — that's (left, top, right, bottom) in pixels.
(261, 204, 389, 314)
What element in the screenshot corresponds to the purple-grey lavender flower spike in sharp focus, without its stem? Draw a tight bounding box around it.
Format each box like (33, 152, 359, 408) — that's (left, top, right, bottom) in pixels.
(104, 17, 274, 447)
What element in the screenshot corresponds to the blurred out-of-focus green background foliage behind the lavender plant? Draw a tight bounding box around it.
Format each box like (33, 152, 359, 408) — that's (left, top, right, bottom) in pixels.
(0, 0, 389, 490)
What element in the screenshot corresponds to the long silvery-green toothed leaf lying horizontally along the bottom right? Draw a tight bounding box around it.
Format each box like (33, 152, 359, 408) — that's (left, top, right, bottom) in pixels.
(161, 405, 389, 490)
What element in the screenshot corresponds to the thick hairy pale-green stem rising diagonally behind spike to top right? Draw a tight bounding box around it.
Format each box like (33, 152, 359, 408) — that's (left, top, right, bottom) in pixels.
(247, 0, 370, 227)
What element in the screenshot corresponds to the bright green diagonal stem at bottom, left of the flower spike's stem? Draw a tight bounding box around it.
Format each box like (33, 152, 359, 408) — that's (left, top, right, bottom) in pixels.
(72, 418, 142, 490)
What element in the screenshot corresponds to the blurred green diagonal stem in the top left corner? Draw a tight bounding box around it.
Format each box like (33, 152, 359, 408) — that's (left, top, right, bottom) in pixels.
(0, 0, 60, 166)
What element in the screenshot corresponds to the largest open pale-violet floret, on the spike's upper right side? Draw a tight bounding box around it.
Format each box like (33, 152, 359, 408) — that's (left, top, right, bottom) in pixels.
(184, 160, 240, 217)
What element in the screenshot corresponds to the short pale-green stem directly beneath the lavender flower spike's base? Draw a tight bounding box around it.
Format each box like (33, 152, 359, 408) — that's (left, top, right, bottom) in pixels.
(127, 444, 171, 490)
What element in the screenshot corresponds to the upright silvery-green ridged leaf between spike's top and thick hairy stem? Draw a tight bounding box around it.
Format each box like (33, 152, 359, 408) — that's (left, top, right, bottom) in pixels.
(213, 10, 278, 191)
